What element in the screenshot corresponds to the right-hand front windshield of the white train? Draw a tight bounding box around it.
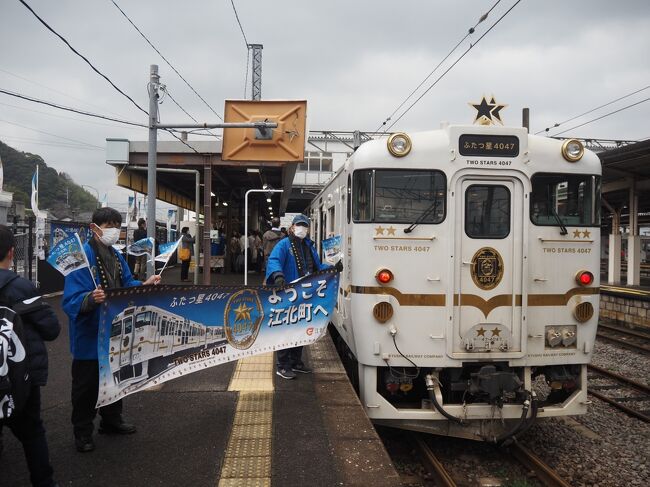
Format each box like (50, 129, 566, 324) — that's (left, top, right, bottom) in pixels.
(530, 173, 600, 226)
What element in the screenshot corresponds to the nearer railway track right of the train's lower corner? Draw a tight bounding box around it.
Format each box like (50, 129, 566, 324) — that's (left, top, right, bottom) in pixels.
(587, 365, 650, 423)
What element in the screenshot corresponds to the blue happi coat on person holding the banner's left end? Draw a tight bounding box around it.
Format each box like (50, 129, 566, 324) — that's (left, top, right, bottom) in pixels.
(63, 243, 142, 360)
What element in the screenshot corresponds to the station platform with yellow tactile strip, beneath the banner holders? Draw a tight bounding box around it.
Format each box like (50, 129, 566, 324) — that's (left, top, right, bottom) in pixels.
(0, 268, 400, 487)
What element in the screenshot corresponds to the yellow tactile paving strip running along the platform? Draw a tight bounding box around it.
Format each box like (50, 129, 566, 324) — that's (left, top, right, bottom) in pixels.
(219, 353, 274, 487)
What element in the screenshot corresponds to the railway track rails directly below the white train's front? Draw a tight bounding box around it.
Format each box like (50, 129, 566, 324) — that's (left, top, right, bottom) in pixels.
(413, 433, 570, 487)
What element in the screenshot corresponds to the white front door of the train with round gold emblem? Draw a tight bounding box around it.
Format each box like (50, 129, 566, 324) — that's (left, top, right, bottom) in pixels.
(451, 177, 524, 358)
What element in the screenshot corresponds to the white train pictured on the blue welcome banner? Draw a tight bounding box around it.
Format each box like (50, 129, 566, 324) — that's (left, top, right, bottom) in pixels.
(109, 305, 226, 385)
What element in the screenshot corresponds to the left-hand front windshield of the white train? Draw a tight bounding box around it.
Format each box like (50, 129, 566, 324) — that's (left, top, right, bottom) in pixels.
(352, 169, 446, 223)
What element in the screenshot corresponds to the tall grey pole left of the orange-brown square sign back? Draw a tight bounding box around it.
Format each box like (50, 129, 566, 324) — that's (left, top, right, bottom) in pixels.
(146, 64, 160, 277)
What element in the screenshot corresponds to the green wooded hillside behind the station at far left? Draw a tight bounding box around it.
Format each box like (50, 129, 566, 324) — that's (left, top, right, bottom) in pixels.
(0, 142, 97, 216)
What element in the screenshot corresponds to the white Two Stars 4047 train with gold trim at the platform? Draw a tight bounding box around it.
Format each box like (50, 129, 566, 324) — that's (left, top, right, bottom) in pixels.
(310, 118, 601, 441)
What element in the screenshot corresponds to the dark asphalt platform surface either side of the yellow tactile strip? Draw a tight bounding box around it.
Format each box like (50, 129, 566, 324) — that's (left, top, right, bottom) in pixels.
(0, 268, 396, 487)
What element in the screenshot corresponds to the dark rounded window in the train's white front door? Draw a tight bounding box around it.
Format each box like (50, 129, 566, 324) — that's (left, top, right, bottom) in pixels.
(465, 184, 510, 238)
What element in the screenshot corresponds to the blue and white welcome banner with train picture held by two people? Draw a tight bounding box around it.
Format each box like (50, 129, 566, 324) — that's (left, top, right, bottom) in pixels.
(97, 271, 338, 407)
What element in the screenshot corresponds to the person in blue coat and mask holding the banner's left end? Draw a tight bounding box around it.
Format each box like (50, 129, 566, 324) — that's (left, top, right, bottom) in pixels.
(63, 207, 160, 452)
